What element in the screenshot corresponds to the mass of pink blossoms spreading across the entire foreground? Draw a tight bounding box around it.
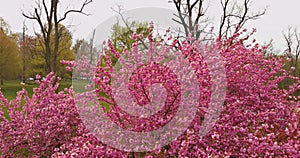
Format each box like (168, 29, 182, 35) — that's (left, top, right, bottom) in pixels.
(0, 27, 300, 158)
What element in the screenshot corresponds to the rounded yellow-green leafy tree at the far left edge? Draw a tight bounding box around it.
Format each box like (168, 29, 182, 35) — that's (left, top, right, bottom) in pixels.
(0, 18, 21, 85)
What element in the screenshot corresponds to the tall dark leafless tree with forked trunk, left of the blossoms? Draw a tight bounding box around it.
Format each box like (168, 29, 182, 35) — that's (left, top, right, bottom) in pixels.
(22, 0, 92, 74)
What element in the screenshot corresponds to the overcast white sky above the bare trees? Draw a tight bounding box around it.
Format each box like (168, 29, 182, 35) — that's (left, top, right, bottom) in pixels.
(0, 0, 300, 49)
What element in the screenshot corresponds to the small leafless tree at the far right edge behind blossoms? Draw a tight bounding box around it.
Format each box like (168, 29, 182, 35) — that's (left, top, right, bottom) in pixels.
(282, 27, 300, 75)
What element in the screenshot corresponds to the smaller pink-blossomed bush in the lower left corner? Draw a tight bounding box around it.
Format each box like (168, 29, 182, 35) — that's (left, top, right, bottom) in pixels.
(0, 73, 84, 157)
